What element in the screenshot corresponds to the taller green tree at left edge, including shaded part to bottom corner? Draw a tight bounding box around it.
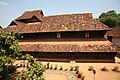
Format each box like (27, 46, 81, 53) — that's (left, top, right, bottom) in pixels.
(0, 30, 19, 80)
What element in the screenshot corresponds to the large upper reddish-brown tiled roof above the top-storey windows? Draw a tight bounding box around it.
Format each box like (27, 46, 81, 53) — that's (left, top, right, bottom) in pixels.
(6, 11, 110, 33)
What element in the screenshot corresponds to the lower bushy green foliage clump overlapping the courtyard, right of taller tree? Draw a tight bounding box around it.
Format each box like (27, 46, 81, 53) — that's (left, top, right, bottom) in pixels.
(16, 54, 45, 80)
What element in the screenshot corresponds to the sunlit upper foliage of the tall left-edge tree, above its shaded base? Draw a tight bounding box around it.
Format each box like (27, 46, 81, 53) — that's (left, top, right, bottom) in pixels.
(0, 31, 19, 65)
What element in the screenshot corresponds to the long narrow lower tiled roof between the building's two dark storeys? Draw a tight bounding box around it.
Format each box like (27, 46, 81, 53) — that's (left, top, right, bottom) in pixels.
(19, 41, 118, 52)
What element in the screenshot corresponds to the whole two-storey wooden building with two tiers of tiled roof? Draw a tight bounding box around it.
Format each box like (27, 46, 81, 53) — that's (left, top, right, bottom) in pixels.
(6, 10, 118, 62)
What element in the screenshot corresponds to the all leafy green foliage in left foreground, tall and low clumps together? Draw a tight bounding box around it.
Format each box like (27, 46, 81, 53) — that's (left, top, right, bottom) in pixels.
(0, 30, 45, 80)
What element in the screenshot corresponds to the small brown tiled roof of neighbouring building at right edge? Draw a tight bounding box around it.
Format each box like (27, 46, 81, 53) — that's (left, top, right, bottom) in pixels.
(106, 27, 120, 37)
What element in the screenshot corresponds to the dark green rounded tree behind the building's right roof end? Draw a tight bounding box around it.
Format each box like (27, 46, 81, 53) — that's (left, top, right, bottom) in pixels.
(98, 10, 120, 27)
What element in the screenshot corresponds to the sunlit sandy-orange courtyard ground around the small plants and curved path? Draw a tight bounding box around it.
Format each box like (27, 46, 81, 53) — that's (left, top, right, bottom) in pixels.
(42, 62, 120, 80)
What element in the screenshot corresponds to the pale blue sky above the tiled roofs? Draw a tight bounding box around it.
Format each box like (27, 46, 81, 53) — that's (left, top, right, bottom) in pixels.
(0, 0, 120, 28)
